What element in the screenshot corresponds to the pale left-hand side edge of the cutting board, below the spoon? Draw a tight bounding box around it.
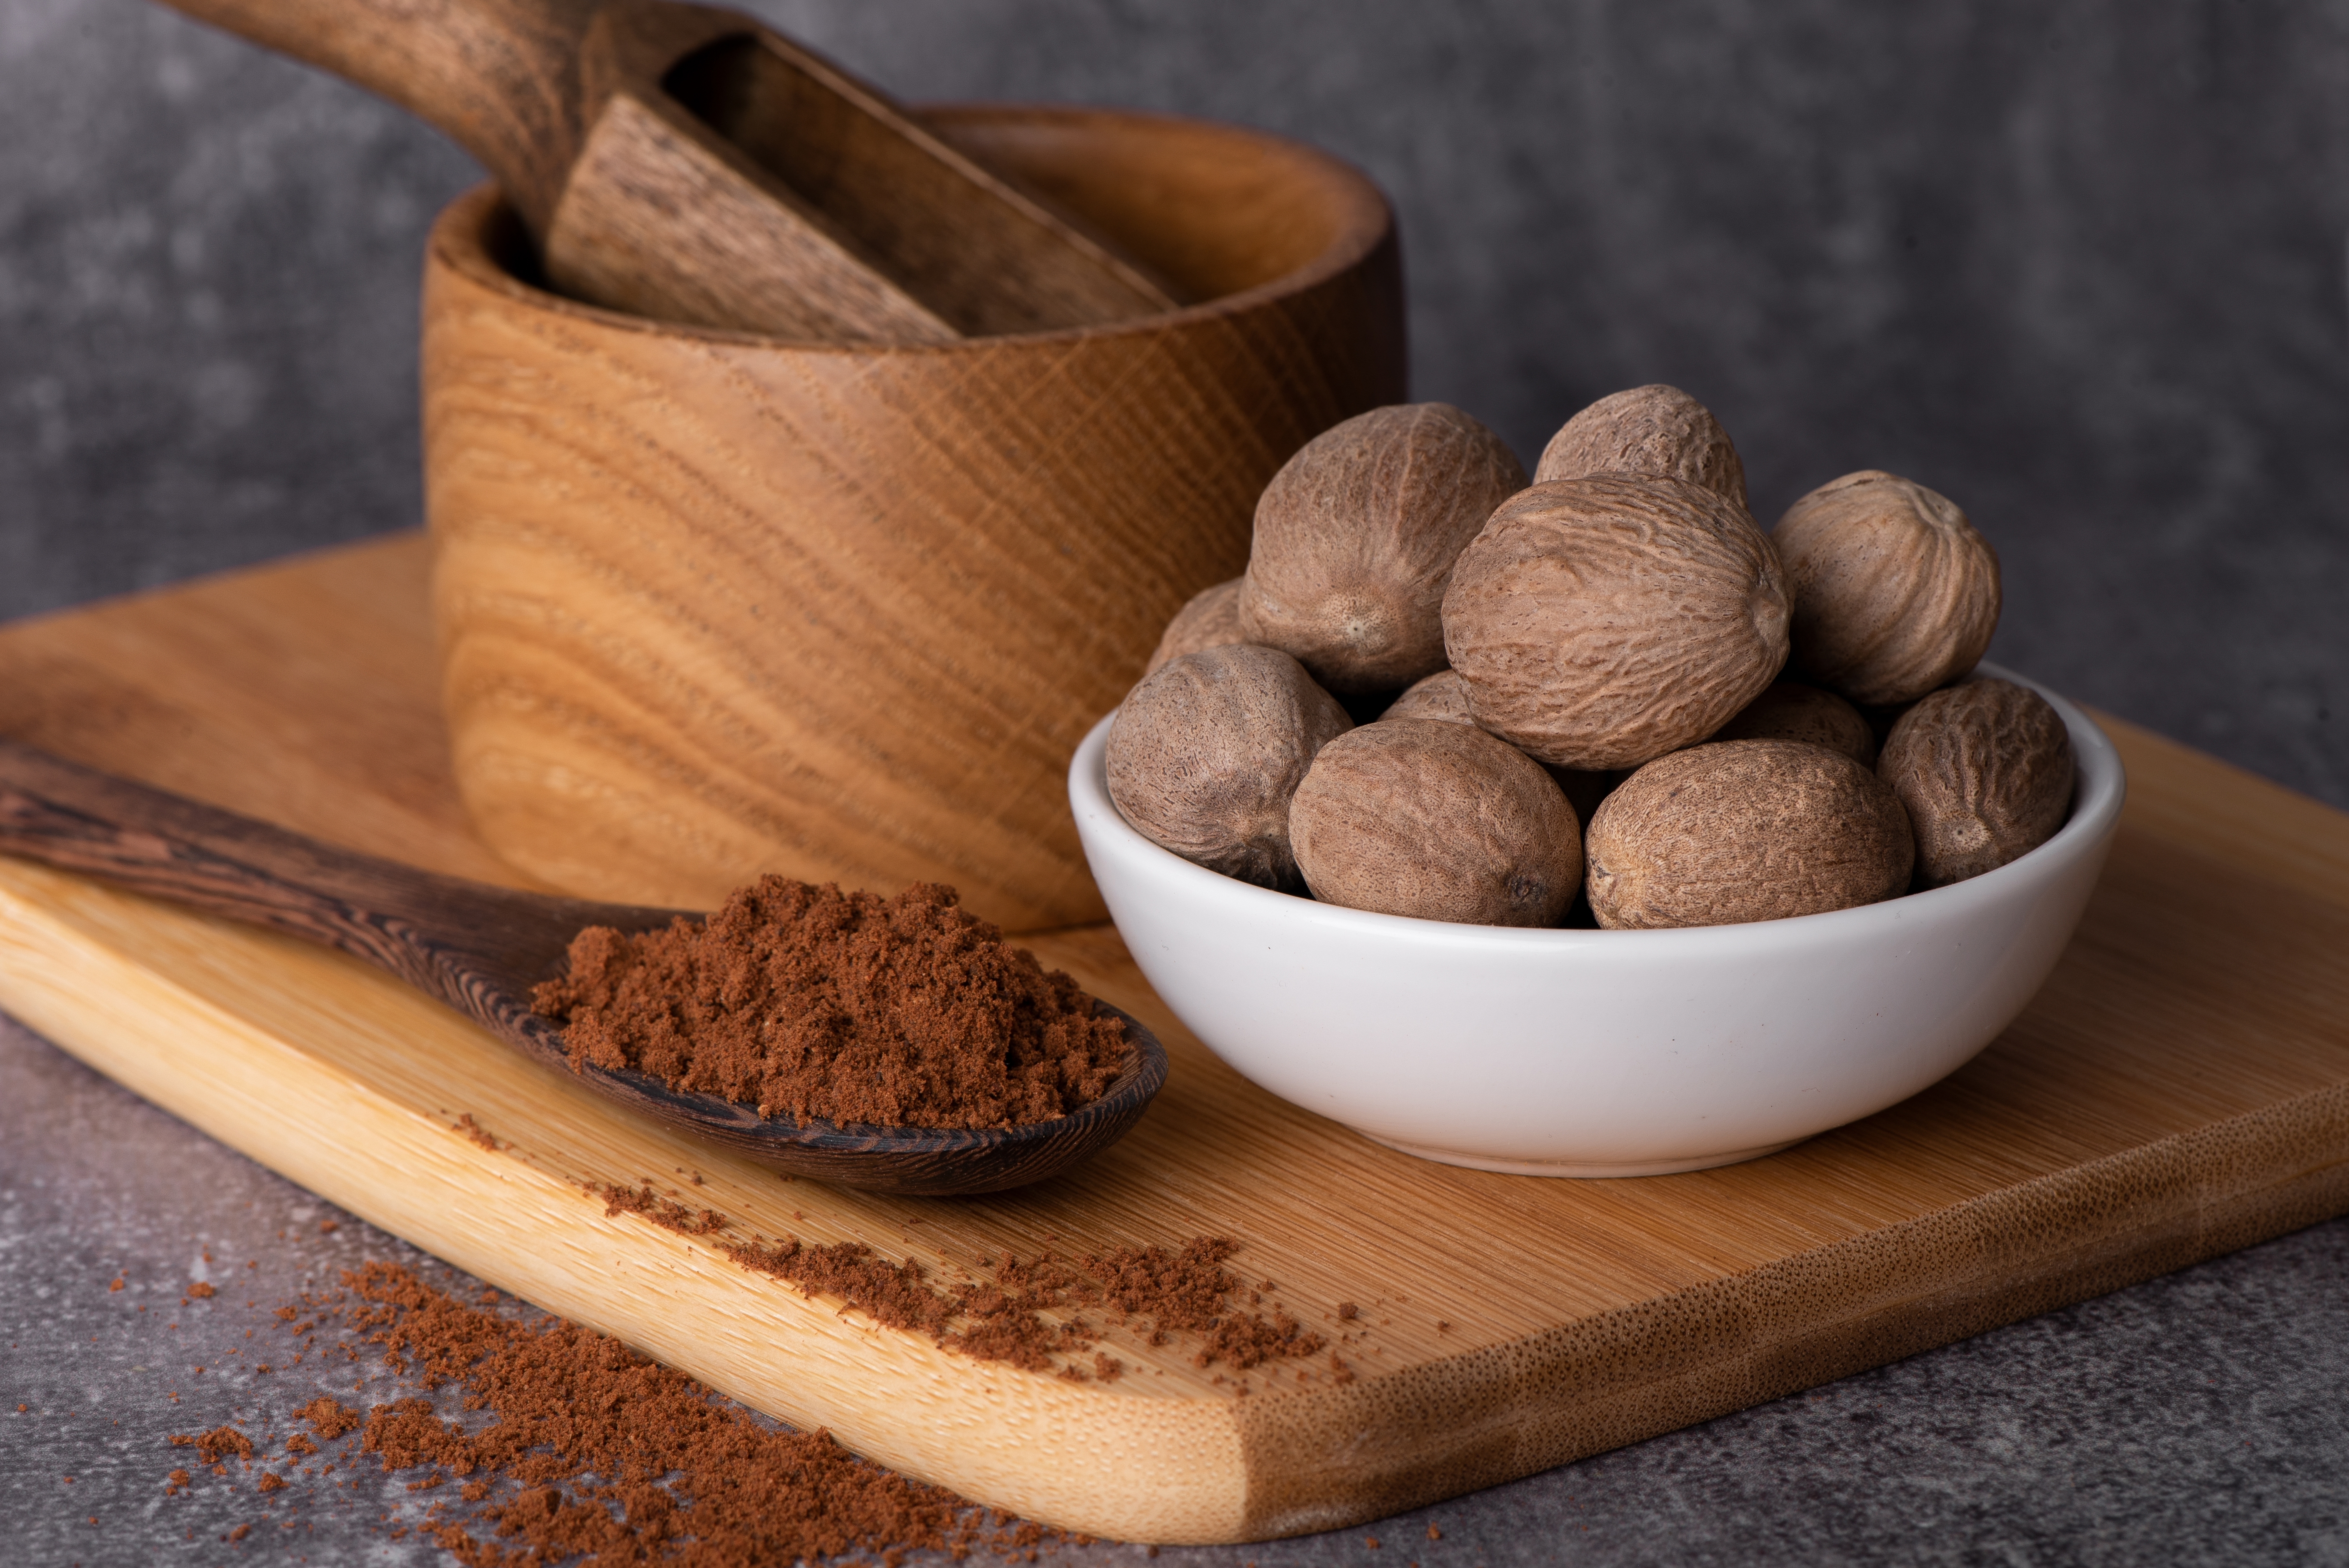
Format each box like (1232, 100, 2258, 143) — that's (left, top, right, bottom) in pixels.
(0, 858, 1245, 1540)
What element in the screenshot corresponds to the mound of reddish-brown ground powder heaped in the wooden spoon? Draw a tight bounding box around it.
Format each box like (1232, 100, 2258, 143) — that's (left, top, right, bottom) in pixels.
(533, 874, 1146, 1129)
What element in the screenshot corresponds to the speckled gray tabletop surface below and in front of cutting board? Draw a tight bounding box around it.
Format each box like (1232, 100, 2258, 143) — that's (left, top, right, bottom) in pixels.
(0, 1020, 2349, 1568)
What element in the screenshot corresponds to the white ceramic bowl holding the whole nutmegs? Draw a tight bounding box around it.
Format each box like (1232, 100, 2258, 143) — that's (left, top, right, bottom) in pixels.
(1069, 665, 2126, 1176)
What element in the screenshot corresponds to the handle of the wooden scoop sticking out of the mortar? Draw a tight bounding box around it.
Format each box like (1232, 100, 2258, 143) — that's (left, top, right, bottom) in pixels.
(162, 0, 599, 233)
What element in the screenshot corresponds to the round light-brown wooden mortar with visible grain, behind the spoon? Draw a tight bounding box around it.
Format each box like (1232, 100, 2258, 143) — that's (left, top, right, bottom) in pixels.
(423, 106, 1405, 929)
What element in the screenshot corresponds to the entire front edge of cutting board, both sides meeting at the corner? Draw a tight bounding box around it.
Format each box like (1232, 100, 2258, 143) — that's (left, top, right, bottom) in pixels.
(18, 863, 2349, 1542)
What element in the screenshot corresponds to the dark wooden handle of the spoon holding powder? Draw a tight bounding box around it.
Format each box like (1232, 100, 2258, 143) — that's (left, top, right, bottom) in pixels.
(0, 741, 620, 1046)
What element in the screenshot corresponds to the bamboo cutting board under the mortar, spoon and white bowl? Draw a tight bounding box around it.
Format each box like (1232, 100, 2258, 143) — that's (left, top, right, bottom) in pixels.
(0, 536, 2349, 1542)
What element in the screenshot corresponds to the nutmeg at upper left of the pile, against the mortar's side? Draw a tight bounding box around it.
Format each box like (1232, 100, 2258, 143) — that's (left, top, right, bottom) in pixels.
(1240, 402, 1525, 694)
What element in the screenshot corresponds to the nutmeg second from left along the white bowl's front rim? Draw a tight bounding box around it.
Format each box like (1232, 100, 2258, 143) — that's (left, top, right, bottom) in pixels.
(1290, 719, 1583, 926)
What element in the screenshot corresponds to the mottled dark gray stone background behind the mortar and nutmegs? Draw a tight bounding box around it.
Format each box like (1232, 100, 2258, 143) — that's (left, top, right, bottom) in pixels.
(0, 0, 2349, 804)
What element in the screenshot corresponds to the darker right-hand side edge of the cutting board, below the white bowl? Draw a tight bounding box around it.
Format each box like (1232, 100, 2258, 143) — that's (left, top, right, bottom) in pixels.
(1212, 1084, 2349, 1535)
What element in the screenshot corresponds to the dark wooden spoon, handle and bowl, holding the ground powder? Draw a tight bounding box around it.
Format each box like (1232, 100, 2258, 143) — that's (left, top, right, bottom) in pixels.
(0, 741, 1168, 1194)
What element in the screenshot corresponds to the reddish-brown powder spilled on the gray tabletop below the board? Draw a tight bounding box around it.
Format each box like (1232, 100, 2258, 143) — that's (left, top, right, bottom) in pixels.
(167, 1262, 1085, 1568)
